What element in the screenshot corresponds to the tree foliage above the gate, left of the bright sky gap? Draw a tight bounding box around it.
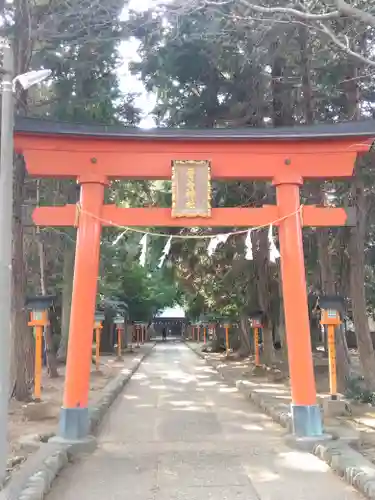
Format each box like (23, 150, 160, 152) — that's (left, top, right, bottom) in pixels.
(13, 0, 143, 124)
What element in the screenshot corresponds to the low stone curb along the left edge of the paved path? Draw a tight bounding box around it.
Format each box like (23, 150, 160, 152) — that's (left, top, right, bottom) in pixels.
(4, 344, 155, 500)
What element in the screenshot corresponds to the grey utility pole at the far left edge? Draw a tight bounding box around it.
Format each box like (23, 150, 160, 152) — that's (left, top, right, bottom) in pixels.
(0, 41, 14, 486)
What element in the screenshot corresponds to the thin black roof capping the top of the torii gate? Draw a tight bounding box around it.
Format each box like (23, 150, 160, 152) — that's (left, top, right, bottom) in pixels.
(15, 117, 375, 141)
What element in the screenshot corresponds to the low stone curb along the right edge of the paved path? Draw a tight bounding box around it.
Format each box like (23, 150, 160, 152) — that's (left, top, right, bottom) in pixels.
(186, 342, 375, 500)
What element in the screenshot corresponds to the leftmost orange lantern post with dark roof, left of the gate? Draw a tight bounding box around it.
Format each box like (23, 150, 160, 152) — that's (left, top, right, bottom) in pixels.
(26, 295, 56, 402)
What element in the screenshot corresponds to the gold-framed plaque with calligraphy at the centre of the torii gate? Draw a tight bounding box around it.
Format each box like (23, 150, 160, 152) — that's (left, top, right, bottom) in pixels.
(172, 160, 211, 217)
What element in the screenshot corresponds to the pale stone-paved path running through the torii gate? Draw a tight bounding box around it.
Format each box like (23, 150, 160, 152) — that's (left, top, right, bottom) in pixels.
(48, 343, 362, 500)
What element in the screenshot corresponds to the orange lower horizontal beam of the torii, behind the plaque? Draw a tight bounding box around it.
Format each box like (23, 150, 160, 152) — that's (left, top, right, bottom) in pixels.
(33, 205, 354, 227)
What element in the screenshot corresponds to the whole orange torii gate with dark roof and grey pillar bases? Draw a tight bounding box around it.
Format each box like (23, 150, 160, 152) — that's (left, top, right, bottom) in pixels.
(15, 119, 375, 440)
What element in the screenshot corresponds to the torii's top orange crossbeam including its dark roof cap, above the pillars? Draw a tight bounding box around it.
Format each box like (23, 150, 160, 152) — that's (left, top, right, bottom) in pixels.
(15, 118, 375, 180)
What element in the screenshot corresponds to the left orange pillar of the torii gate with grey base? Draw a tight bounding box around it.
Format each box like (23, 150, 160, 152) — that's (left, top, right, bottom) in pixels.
(59, 176, 106, 441)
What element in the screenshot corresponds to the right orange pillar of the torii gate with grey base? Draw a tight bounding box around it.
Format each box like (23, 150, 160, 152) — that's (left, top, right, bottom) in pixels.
(273, 176, 323, 437)
